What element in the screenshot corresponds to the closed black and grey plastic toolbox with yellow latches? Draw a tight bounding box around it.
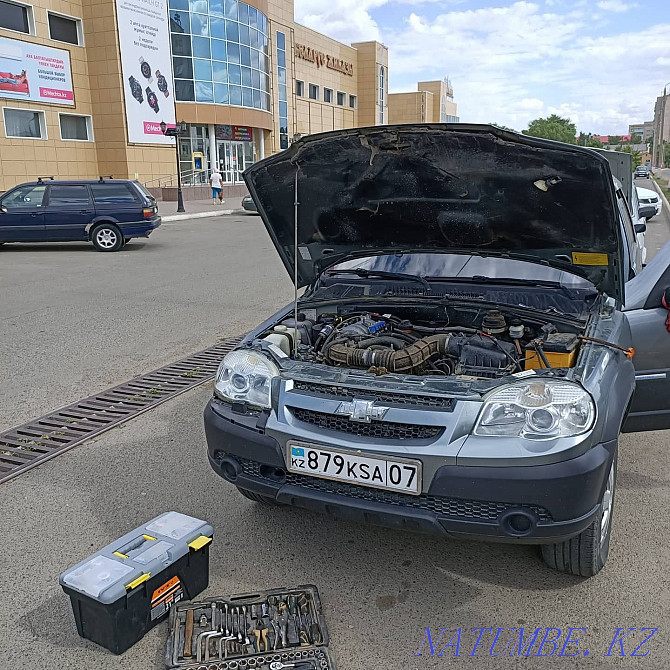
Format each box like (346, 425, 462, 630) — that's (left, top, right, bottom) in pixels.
(59, 512, 214, 654)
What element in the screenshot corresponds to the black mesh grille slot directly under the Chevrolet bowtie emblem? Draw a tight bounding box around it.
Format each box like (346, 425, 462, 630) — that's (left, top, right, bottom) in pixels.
(290, 407, 444, 440)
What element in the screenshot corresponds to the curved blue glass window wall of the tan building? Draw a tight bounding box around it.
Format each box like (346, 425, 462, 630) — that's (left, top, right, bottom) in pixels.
(169, 0, 271, 111)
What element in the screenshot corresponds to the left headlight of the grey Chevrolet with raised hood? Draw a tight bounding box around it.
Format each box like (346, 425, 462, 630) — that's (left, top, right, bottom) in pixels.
(214, 349, 279, 407)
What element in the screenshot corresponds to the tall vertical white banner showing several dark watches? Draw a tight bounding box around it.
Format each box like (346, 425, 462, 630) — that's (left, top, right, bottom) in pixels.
(116, 0, 175, 144)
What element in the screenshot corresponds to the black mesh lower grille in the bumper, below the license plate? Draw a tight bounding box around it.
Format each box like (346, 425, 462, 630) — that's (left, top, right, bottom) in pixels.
(238, 458, 553, 523)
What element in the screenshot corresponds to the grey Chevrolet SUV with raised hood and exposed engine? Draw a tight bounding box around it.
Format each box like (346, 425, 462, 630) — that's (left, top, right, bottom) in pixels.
(204, 124, 670, 577)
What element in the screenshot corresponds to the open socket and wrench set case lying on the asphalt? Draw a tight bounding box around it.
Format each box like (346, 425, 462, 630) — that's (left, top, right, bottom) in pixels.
(165, 585, 335, 670)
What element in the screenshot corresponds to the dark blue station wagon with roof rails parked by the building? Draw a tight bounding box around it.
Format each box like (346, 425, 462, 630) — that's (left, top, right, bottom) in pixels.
(0, 177, 161, 251)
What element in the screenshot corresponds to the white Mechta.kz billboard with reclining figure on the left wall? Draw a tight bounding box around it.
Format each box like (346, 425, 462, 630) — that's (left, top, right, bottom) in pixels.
(0, 37, 74, 105)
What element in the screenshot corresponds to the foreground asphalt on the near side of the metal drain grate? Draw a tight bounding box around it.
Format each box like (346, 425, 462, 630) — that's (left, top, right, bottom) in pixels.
(0, 385, 670, 670)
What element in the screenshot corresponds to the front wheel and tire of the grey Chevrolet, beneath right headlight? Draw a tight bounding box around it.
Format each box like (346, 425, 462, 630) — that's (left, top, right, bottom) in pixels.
(541, 452, 617, 577)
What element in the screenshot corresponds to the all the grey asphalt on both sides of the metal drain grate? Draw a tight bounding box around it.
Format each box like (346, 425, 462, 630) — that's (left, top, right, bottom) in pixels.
(0, 201, 670, 670)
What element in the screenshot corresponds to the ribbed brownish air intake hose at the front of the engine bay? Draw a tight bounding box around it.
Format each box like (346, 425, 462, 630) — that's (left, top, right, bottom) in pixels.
(327, 334, 450, 372)
